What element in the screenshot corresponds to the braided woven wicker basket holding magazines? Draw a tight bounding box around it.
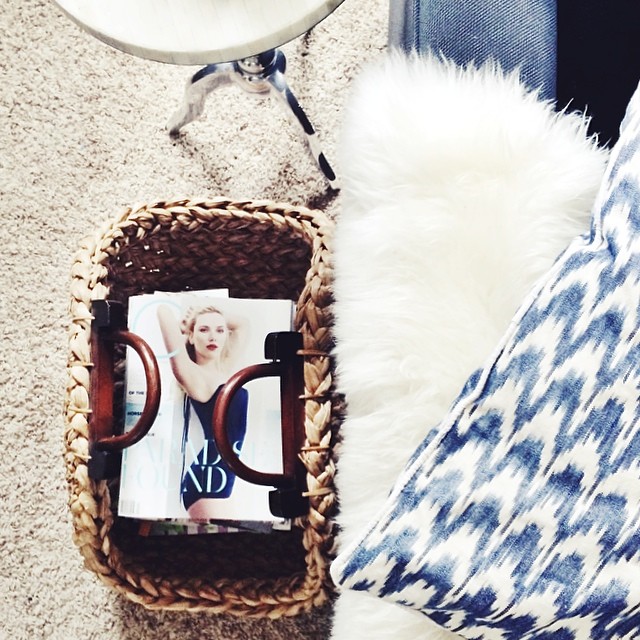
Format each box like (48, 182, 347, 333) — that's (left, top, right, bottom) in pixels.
(65, 199, 339, 618)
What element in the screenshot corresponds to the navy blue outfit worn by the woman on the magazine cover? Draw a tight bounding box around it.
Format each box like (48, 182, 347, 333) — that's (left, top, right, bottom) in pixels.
(180, 385, 249, 509)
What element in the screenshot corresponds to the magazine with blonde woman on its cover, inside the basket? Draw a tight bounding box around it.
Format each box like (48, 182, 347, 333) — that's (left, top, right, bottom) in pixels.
(118, 290, 294, 533)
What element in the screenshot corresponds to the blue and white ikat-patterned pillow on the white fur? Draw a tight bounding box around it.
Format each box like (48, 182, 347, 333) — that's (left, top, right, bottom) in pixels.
(331, 82, 640, 640)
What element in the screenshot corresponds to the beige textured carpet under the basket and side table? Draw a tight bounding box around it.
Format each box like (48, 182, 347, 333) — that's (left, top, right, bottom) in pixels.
(0, 0, 387, 640)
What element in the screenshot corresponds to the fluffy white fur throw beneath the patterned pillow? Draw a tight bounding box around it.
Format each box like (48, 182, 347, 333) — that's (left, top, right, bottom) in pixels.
(332, 53, 606, 640)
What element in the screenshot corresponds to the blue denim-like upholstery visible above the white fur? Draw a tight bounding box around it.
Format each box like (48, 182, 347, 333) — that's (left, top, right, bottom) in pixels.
(389, 0, 557, 100)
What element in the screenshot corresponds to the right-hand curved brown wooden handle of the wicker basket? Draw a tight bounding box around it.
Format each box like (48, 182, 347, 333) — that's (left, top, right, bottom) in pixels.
(213, 332, 307, 517)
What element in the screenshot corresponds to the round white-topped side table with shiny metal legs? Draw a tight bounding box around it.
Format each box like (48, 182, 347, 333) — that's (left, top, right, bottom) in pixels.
(54, 0, 343, 187)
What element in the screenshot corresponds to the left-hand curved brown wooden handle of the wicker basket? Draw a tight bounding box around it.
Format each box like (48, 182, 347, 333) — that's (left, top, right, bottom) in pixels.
(89, 300, 160, 464)
